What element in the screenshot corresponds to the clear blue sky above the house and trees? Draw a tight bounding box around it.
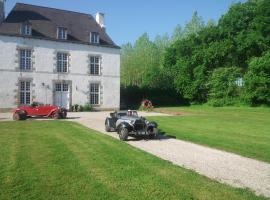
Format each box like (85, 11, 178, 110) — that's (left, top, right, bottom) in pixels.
(6, 0, 245, 45)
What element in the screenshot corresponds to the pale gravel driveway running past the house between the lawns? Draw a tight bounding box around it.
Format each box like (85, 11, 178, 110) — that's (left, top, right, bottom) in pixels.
(0, 112, 270, 197)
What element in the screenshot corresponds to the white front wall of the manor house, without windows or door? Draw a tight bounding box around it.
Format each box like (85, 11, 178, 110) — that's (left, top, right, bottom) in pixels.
(0, 35, 120, 109)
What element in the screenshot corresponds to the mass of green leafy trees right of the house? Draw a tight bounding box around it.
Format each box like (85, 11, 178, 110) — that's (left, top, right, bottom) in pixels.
(121, 0, 270, 105)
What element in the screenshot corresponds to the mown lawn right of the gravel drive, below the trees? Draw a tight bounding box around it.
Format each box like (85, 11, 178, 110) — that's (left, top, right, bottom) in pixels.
(151, 106, 270, 162)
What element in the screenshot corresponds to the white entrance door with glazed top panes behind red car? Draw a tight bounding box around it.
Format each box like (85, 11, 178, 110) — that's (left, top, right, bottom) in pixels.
(54, 83, 70, 109)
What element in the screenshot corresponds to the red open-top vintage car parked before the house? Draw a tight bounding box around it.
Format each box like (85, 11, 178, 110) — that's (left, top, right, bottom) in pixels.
(13, 102, 67, 120)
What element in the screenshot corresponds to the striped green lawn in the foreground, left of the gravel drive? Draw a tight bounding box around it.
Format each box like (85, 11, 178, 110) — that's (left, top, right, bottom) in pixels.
(0, 121, 263, 200)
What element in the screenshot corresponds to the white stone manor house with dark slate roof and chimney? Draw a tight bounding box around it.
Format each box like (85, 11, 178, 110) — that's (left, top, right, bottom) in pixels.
(0, 0, 120, 110)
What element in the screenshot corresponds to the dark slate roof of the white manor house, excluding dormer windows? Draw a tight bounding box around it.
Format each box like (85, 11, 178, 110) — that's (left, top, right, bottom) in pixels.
(0, 3, 119, 48)
